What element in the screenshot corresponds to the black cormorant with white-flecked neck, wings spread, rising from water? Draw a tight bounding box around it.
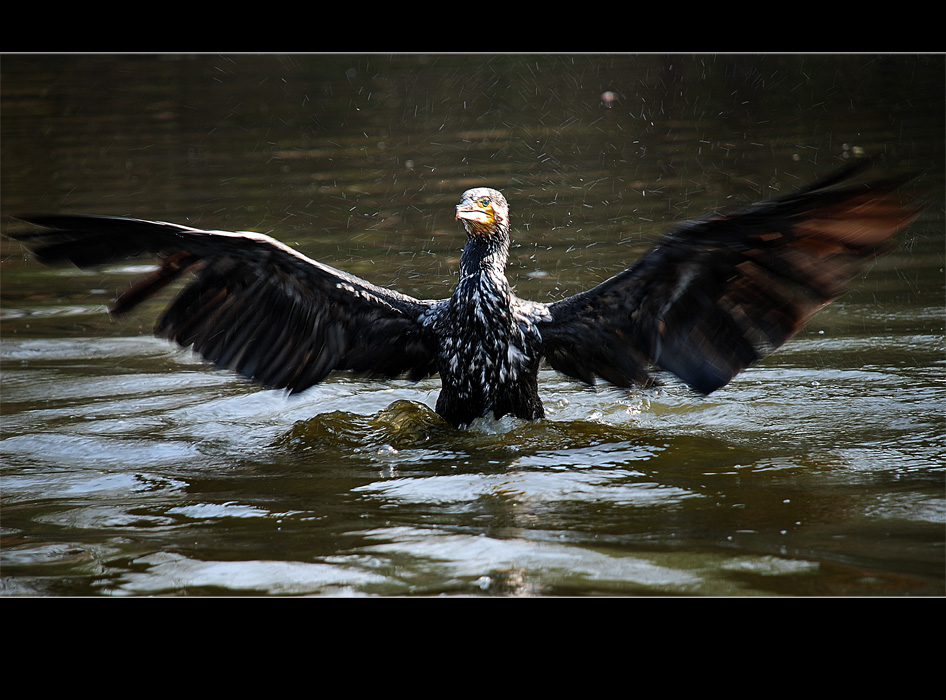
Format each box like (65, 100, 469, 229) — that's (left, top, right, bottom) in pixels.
(13, 161, 917, 426)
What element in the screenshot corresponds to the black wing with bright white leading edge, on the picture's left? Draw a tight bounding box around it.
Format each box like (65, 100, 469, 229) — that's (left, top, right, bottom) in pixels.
(12, 216, 436, 392)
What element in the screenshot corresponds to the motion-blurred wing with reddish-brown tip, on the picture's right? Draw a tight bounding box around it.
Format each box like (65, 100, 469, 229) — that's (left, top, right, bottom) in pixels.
(538, 163, 917, 394)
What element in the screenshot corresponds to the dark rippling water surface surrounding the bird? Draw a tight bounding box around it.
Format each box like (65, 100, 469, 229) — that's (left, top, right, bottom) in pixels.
(0, 55, 946, 595)
